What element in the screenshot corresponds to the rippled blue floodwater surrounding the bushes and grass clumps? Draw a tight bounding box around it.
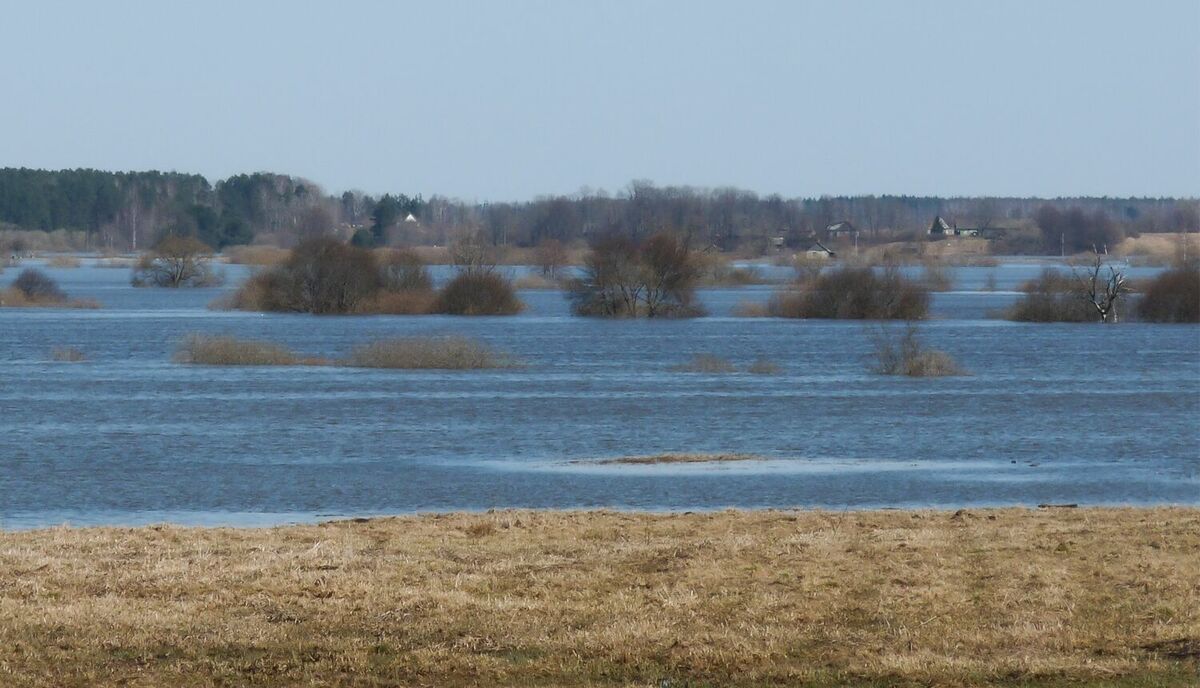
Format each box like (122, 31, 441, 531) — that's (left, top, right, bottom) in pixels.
(0, 256, 1200, 528)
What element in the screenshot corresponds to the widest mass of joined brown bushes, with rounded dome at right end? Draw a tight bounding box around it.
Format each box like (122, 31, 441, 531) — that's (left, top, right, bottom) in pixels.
(225, 238, 522, 315)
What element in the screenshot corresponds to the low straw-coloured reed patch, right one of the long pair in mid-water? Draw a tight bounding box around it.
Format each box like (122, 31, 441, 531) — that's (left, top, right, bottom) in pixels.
(347, 337, 512, 370)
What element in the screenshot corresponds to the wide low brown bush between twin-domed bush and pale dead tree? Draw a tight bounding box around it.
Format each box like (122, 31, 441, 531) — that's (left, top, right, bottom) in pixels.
(767, 267, 929, 321)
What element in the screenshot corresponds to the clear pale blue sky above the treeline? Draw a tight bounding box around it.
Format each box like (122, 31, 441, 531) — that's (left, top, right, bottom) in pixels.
(0, 0, 1200, 202)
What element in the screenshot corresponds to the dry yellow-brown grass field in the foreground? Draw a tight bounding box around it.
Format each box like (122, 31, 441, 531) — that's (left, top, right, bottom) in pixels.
(0, 508, 1200, 687)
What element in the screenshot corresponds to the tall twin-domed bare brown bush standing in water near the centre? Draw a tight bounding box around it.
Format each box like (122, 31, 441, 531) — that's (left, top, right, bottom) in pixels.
(569, 233, 703, 318)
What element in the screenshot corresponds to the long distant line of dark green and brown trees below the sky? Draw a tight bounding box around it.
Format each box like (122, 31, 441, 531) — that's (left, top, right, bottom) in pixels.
(0, 168, 1200, 250)
